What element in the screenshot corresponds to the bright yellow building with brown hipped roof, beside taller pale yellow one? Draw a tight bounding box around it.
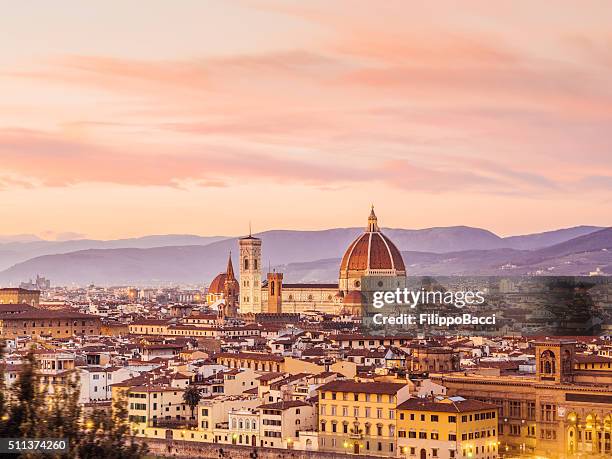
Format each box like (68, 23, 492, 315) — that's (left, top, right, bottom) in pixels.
(397, 397, 498, 459)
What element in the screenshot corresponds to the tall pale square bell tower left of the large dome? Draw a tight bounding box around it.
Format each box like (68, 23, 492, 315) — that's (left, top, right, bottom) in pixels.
(240, 234, 262, 314)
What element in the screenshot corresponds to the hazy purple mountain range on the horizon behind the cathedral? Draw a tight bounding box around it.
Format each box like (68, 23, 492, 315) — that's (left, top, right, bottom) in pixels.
(0, 227, 612, 285)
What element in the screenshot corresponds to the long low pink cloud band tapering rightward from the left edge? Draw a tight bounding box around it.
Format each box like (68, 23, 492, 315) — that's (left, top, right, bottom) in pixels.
(0, 129, 369, 187)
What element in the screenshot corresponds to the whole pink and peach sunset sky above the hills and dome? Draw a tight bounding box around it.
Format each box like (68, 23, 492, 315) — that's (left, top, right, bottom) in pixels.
(0, 0, 612, 238)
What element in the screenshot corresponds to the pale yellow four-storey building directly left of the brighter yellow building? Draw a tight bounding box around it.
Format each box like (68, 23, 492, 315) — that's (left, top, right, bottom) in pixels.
(319, 380, 409, 457)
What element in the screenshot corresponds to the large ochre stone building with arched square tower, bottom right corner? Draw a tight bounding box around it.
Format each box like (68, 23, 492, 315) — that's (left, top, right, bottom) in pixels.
(430, 339, 612, 459)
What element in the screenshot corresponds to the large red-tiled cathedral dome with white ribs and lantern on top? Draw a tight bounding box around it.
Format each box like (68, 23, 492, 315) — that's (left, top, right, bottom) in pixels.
(340, 208, 406, 275)
